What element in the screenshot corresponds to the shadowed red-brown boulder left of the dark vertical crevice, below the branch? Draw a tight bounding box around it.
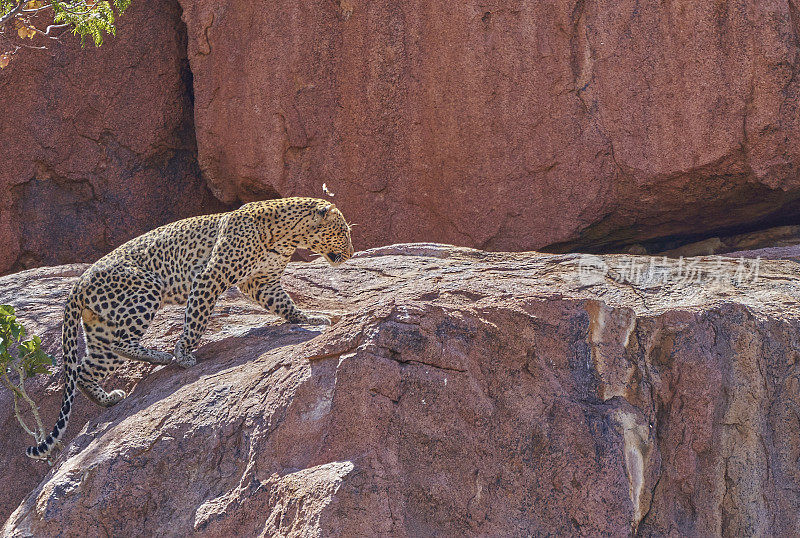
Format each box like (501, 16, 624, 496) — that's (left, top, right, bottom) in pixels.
(0, 0, 231, 274)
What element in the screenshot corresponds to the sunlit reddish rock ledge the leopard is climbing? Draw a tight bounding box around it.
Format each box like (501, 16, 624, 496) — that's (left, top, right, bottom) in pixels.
(0, 244, 800, 536)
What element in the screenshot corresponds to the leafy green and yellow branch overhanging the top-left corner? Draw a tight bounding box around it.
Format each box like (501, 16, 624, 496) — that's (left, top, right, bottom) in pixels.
(0, 0, 131, 69)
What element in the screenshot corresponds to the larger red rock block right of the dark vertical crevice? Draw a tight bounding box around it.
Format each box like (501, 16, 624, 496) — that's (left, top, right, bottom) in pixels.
(181, 0, 800, 250)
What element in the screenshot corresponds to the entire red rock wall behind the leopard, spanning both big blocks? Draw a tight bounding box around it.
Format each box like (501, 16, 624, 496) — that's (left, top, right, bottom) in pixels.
(0, 0, 800, 272)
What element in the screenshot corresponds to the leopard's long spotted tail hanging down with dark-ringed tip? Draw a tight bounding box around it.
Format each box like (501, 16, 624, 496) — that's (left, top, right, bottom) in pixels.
(26, 281, 83, 459)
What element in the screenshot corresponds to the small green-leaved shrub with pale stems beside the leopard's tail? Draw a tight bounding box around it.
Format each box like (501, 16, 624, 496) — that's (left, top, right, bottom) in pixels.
(0, 305, 56, 463)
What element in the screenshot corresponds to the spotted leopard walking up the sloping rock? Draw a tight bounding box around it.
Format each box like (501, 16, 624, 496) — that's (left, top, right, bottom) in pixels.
(26, 197, 353, 459)
